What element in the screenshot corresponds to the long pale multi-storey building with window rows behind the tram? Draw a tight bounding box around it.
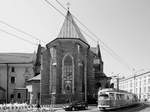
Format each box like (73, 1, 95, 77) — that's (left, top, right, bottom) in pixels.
(113, 71, 150, 100)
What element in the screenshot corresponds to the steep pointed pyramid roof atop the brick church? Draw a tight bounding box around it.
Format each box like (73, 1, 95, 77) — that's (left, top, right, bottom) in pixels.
(57, 11, 87, 43)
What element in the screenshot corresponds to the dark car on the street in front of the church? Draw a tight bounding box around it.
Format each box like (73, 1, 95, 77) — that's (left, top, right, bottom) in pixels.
(63, 102, 88, 111)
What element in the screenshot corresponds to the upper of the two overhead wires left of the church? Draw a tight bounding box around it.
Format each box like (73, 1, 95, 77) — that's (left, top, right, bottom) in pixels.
(0, 20, 46, 43)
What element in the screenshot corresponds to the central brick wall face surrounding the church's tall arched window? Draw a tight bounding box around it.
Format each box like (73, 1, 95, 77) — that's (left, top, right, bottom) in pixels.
(57, 41, 82, 103)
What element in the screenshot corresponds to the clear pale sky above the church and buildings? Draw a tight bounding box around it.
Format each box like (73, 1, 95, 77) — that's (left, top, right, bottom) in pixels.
(0, 0, 150, 76)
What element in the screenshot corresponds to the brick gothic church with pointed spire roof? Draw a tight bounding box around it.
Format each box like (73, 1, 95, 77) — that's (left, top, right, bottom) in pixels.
(40, 11, 110, 104)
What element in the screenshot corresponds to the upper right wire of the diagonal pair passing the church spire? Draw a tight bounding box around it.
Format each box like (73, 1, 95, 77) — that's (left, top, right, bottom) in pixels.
(55, 0, 133, 70)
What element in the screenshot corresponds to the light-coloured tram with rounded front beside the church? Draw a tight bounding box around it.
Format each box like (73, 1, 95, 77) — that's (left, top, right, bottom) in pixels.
(98, 88, 139, 110)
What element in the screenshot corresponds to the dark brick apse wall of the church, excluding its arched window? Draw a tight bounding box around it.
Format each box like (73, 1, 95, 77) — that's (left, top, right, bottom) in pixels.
(41, 39, 108, 104)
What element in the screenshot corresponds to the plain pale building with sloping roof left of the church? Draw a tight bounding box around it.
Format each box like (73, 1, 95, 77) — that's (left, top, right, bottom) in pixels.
(0, 53, 34, 103)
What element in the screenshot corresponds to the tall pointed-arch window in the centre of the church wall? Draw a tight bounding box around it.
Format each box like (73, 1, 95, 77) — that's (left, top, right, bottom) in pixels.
(62, 54, 74, 94)
